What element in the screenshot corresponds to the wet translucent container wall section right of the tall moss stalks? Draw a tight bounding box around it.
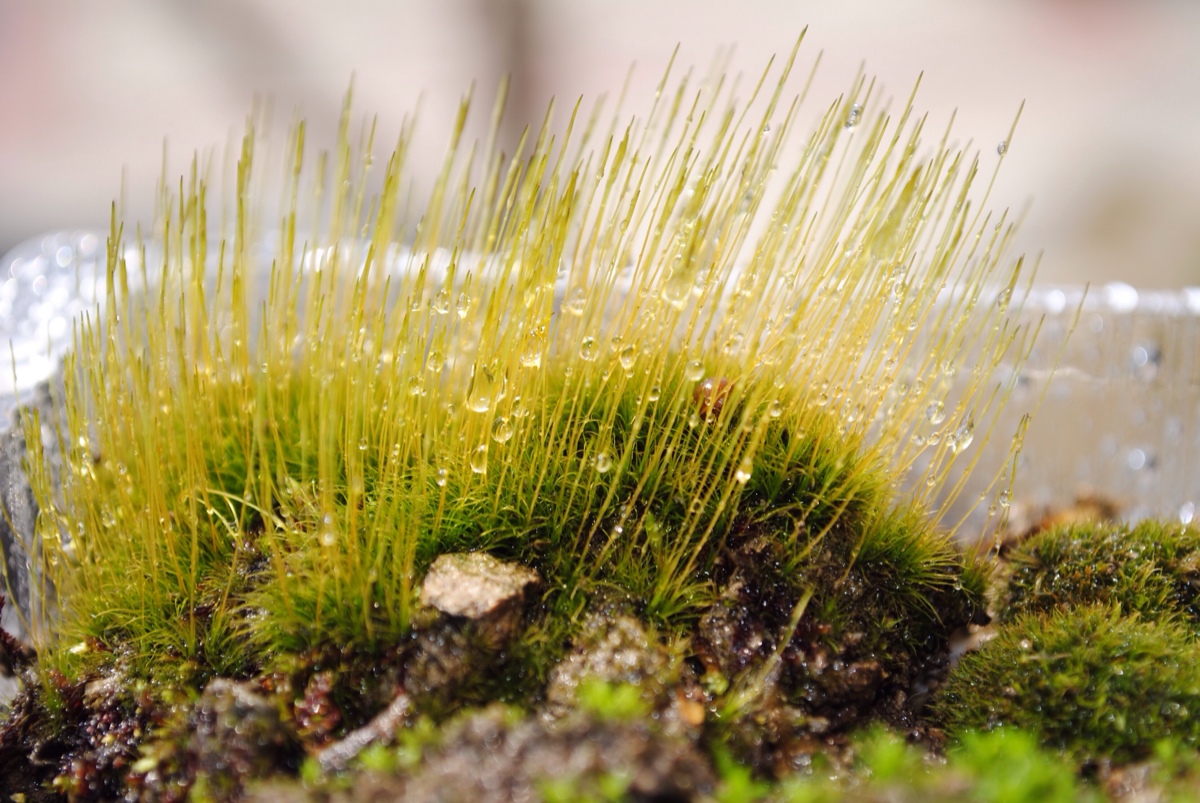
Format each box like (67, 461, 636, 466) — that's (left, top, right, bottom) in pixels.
(945, 283, 1200, 532)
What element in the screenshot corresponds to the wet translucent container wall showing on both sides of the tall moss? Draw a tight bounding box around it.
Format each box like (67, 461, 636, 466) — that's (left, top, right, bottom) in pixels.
(0, 232, 1200, 540)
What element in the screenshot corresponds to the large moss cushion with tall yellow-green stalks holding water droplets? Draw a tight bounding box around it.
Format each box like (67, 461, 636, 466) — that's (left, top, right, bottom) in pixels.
(0, 42, 1060, 796)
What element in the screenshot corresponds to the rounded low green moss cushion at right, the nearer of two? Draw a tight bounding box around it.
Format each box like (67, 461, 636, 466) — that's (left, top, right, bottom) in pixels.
(934, 606, 1200, 762)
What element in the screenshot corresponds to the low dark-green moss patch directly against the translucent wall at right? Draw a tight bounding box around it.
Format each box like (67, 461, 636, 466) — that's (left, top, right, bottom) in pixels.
(1001, 521, 1200, 633)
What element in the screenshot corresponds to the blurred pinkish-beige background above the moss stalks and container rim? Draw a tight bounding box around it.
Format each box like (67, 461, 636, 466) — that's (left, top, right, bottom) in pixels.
(0, 0, 1200, 288)
